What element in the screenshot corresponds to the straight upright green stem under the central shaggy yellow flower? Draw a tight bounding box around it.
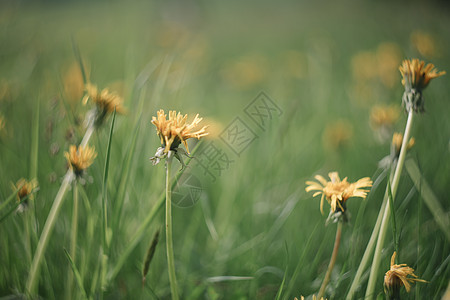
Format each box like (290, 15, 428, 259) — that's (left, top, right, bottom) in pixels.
(166, 155, 179, 300)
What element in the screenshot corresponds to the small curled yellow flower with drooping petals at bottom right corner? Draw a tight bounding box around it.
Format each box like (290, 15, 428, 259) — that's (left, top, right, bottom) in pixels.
(384, 252, 427, 293)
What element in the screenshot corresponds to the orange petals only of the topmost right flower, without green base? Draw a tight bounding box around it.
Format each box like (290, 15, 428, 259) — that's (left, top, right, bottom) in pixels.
(399, 58, 445, 90)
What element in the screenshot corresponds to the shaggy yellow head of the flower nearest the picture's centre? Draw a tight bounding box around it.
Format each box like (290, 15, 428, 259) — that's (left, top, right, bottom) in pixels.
(152, 109, 209, 153)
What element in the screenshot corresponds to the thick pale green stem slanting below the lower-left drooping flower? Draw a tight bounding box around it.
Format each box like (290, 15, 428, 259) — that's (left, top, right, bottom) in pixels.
(26, 170, 75, 296)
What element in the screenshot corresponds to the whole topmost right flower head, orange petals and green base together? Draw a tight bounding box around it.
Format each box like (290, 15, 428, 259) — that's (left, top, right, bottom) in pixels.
(399, 59, 445, 112)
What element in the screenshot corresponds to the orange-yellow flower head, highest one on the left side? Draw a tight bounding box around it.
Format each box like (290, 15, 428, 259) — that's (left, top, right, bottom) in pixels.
(83, 83, 125, 126)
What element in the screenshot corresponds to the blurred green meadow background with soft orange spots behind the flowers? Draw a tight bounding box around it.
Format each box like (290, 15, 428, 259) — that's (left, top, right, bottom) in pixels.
(0, 0, 450, 299)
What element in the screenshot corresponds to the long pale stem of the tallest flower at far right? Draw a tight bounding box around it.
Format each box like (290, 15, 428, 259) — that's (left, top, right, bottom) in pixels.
(366, 109, 414, 299)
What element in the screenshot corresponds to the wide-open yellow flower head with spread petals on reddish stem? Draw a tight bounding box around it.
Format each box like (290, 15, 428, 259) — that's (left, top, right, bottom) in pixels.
(305, 172, 372, 214)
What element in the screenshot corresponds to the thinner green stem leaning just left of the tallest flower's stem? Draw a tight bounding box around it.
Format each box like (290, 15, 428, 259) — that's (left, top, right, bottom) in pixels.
(345, 170, 394, 300)
